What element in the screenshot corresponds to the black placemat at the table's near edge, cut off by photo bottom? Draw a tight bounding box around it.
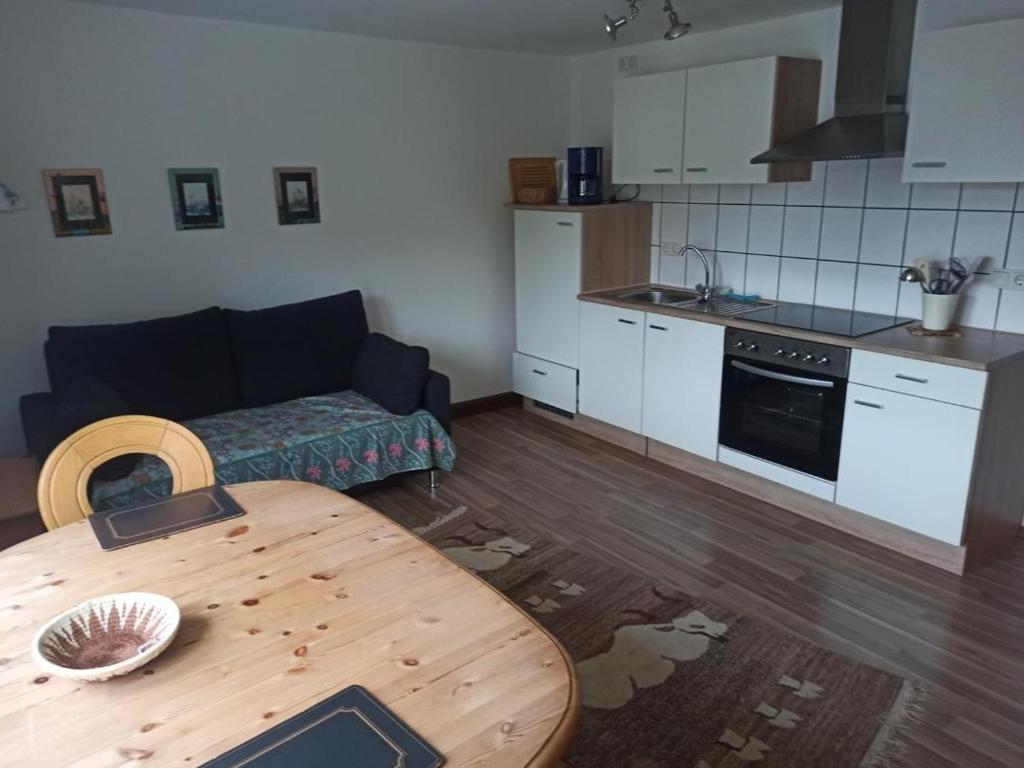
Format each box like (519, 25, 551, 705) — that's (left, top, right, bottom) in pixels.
(202, 685, 444, 768)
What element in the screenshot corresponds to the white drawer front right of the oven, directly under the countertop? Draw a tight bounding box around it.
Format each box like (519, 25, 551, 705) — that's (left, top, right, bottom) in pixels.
(850, 349, 988, 409)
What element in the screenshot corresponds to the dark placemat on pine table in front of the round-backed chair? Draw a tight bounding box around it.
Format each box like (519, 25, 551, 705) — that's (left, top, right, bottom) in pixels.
(89, 485, 246, 550)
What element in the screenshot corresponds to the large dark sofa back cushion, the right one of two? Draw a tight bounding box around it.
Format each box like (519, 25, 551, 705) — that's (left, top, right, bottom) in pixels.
(224, 291, 369, 408)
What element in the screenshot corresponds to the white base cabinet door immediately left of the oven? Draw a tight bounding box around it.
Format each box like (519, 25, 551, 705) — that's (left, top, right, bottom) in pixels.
(642, 314, 725, 461)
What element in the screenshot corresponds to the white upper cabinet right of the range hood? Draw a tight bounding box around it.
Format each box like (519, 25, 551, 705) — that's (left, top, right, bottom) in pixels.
(903, 18, 1024, 182)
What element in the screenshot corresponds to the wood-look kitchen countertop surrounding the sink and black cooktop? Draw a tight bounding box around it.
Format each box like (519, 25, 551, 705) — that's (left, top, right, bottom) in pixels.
(579, 285, 1024, 371)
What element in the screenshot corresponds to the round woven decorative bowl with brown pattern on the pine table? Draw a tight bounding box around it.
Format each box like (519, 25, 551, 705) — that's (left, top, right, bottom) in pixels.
(32, 592, 181, 681)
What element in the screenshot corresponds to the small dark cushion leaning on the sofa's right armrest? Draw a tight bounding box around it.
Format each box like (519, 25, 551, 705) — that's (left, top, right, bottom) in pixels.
(352, 334, 430, 416)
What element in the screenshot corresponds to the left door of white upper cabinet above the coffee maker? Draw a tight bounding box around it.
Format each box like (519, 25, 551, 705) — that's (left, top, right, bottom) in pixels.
(611, 70, 686, 184)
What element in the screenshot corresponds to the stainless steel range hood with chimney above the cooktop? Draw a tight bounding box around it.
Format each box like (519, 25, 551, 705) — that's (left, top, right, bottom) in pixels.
(751, 0, 918, 163)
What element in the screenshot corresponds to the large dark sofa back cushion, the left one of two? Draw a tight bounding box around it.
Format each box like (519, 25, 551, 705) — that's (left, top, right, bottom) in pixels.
(46, 307, 240, 421)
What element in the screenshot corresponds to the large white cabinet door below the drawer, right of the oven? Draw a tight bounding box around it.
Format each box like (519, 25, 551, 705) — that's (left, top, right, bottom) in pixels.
(836, 383, 981, 545)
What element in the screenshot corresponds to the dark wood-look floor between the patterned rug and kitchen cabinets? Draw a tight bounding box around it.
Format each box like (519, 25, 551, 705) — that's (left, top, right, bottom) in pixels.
(360, 409, 1024, 768)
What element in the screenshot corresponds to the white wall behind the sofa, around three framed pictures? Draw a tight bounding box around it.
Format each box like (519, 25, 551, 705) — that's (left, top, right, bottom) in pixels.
(0, 0, 570, 455)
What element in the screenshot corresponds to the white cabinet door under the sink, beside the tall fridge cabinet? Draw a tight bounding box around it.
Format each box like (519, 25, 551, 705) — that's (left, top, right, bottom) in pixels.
(580, 301, 644, 432)
